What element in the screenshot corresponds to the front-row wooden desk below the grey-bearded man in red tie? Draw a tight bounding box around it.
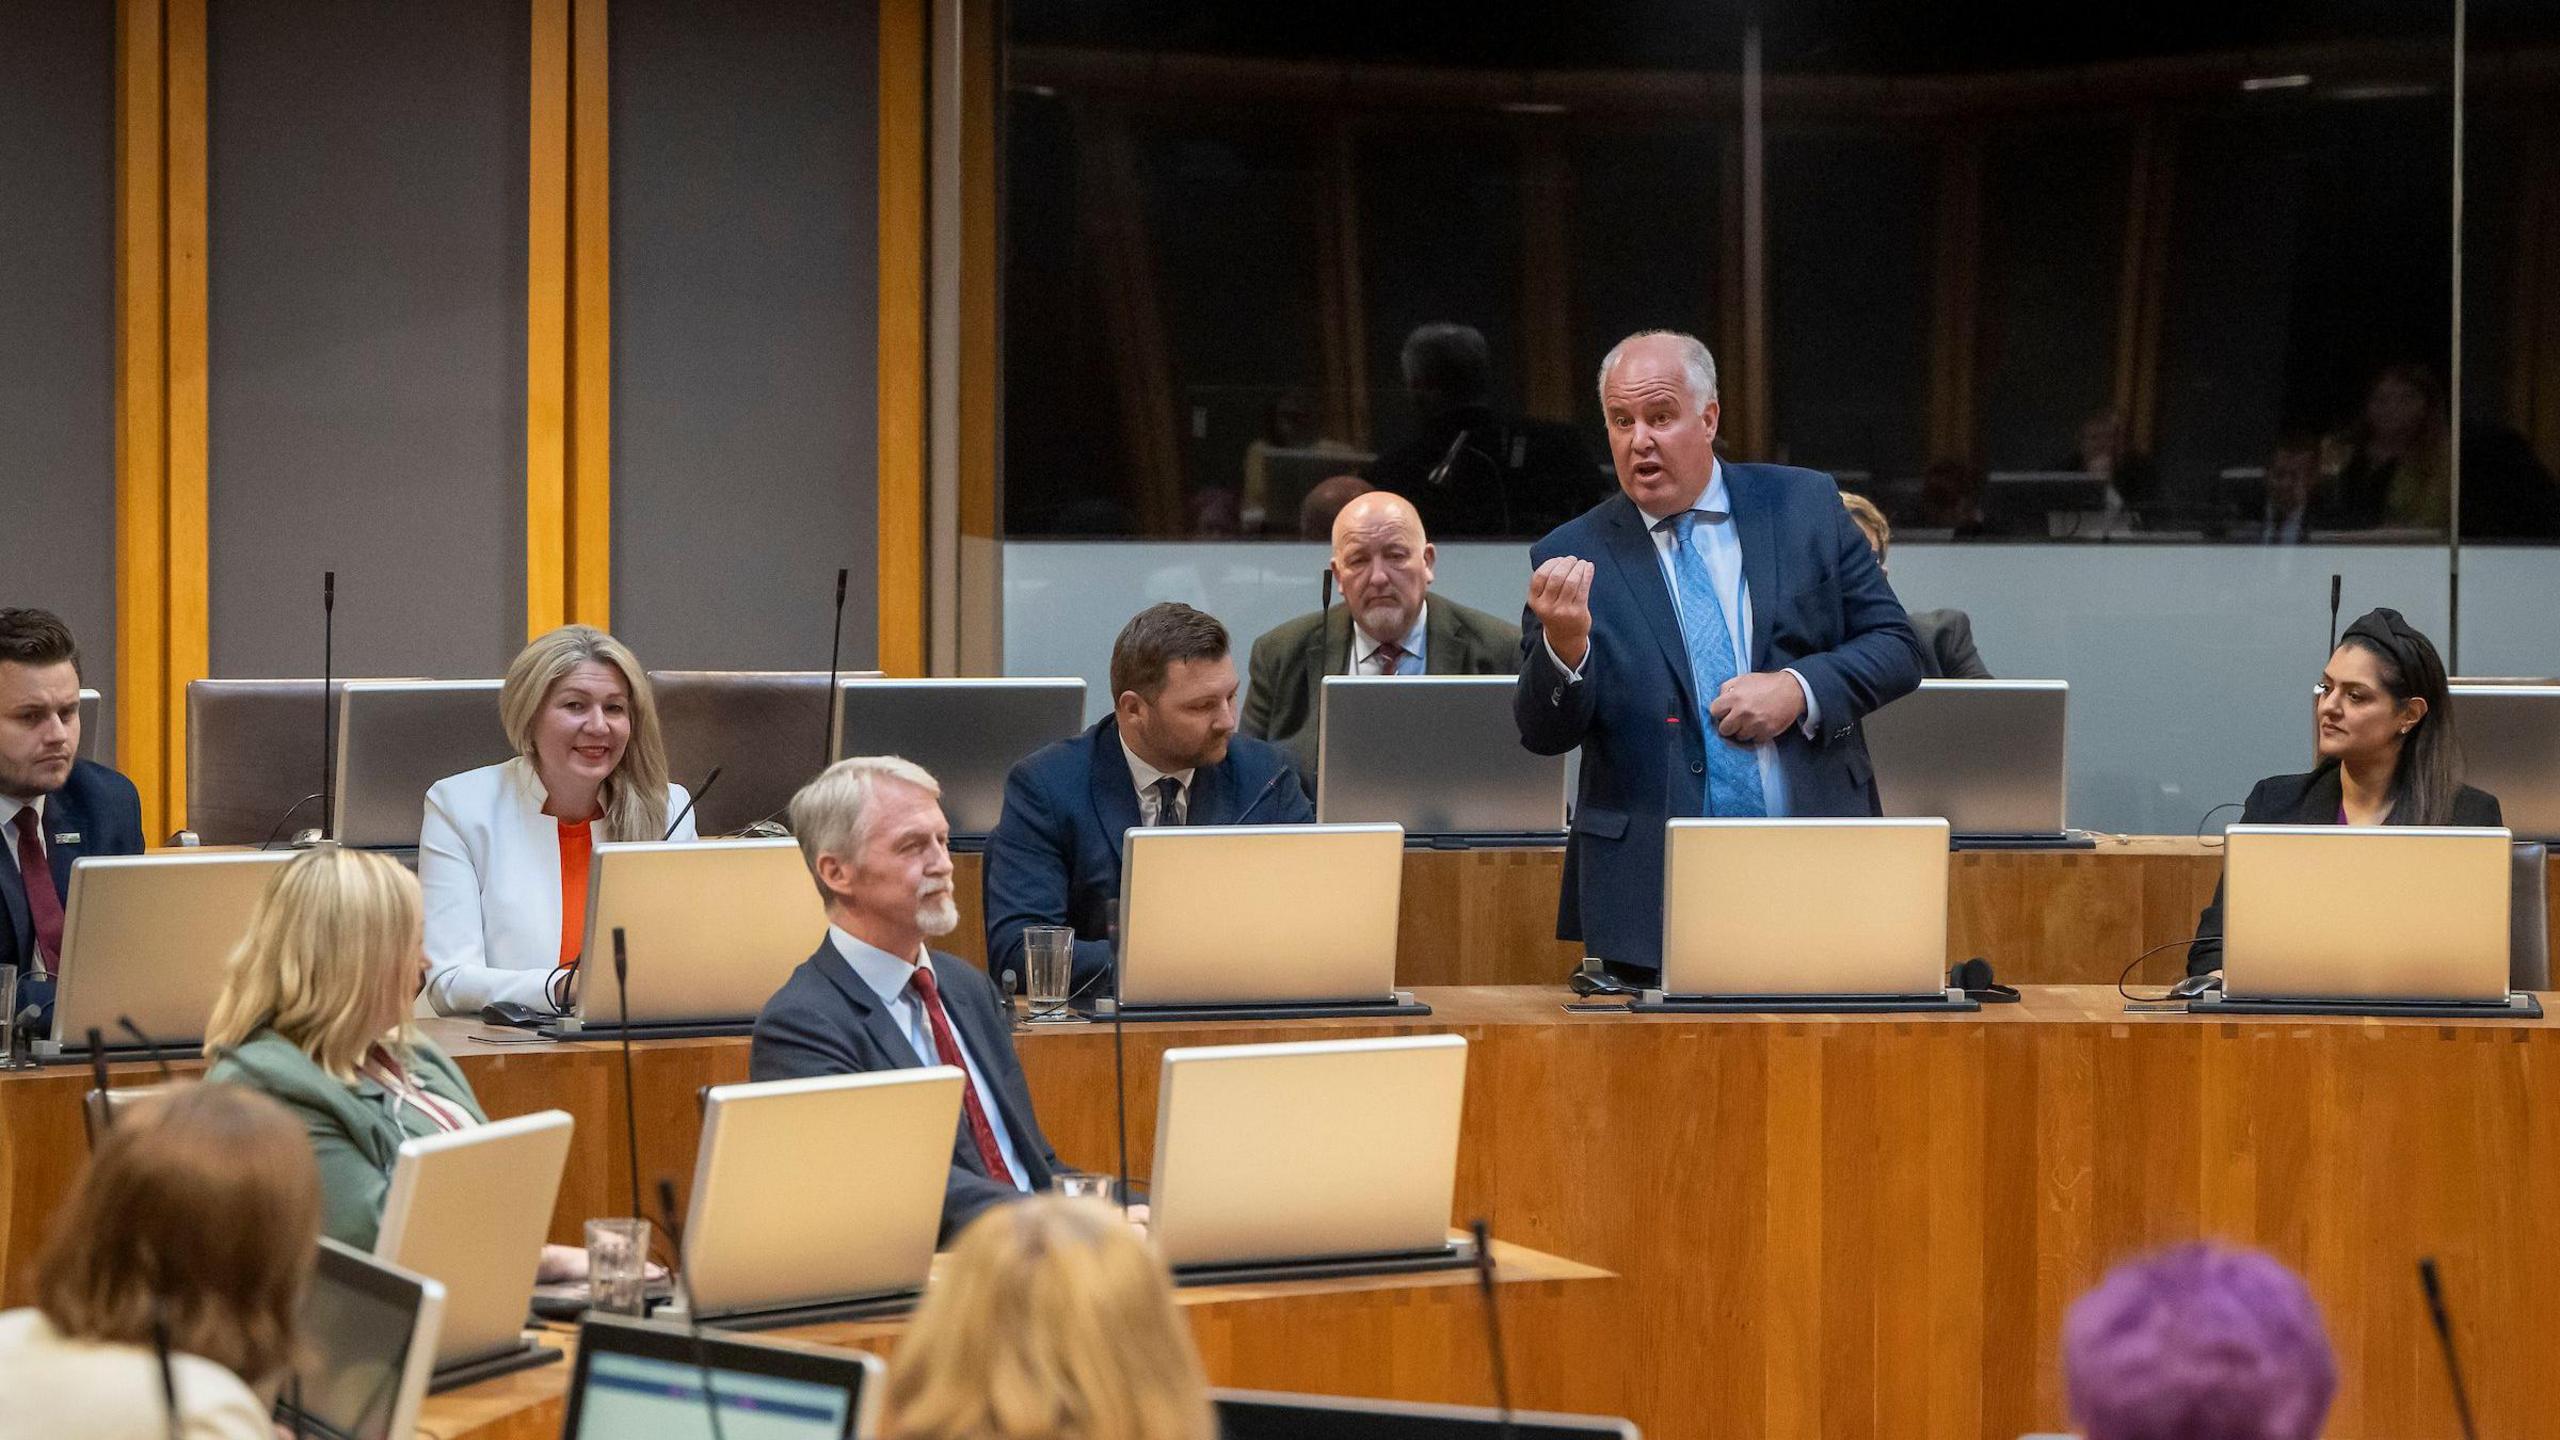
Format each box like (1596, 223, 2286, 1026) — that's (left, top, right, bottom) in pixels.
(417, 1240, 1613, 1440)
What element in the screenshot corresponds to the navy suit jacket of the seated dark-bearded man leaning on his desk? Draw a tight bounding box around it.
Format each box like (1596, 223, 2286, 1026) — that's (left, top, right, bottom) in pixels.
(986, 715, 1316, 994)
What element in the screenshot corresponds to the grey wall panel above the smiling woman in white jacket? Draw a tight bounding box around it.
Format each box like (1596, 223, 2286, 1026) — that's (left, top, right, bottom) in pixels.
(612, 0, 878, 669)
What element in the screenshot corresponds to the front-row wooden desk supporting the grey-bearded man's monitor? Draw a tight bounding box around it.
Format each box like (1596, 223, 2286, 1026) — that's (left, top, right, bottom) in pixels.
(417, 1240, 1610, 1440)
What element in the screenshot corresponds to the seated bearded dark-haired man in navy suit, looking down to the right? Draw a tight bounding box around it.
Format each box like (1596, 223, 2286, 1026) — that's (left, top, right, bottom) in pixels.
(986, 602, 1316, 997)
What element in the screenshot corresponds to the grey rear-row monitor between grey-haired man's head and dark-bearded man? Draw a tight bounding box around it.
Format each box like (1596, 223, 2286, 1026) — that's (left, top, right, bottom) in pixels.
(835, 676, 1085, 840)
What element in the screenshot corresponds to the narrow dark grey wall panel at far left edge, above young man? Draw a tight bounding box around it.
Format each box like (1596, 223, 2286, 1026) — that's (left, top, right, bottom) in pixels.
(0, 5, 115, 756)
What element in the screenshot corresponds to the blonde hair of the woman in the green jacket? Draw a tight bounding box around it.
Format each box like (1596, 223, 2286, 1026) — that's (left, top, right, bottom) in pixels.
(205, 846, 425, 1084)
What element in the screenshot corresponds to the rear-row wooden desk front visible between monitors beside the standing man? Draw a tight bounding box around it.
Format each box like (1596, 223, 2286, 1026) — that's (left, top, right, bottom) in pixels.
(950, 835, 2560, 984)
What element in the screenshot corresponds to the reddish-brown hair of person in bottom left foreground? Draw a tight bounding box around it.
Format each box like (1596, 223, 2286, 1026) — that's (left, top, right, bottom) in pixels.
(36, 1084, 320, 1383)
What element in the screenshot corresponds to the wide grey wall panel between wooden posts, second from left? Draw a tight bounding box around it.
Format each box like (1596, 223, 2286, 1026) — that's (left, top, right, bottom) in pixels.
(207, 0, 530, 676)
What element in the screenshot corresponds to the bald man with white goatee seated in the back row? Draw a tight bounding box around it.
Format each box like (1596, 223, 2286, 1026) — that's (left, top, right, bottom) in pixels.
(1244, 489, 1521, 794)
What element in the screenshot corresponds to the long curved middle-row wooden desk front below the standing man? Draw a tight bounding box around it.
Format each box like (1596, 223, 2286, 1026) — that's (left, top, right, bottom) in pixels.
(0, 989, 2560, 1440)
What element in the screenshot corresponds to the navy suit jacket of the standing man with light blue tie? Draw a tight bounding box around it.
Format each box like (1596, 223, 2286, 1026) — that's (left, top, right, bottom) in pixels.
(1513, 464, 1923, 969)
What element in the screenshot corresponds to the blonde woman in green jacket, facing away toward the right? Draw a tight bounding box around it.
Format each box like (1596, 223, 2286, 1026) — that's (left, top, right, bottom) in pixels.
(205, 846, 586, 1281)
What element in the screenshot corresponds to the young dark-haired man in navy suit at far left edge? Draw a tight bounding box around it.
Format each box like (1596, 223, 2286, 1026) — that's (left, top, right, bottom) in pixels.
(0, 610, 143, 1020)
